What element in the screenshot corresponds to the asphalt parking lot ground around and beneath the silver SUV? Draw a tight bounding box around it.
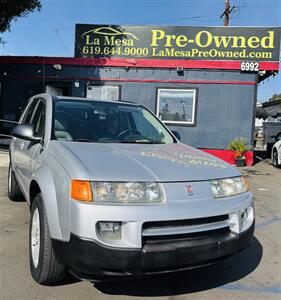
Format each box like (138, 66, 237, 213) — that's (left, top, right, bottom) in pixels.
(0, 153, 281, 300)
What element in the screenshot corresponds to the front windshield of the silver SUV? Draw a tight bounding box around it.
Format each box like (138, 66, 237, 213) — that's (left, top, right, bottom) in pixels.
(52, 100, 174, 144)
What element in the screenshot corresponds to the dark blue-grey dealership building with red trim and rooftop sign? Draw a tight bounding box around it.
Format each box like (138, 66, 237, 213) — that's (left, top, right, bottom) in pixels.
(0, 25, 280, 165)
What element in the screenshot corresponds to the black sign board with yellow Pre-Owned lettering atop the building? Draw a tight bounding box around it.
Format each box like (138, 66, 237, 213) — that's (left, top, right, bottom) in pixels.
(75, 24, 281, 63)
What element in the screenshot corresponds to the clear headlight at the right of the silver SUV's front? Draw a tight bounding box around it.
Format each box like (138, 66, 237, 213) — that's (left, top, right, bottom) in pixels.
(210, 177, 249, 198)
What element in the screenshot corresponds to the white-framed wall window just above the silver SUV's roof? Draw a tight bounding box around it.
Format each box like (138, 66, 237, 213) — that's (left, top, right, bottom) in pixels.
(86, 85, 120, 101)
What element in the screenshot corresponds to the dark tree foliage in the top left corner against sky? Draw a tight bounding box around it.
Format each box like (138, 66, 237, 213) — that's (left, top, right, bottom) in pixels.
(0, 0, 41, 32)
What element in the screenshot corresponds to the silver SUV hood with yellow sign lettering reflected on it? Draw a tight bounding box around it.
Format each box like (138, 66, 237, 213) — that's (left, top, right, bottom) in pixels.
(49, 141, 240, 182)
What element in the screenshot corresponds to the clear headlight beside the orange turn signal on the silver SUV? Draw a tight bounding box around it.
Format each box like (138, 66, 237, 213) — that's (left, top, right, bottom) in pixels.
(91, 182, 164, 204)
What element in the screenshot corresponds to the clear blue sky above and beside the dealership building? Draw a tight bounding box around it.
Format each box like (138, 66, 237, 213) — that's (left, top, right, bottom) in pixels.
(0, 0, 281, 102)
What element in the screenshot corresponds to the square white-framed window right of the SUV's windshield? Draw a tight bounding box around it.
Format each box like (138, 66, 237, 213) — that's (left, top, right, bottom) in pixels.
(156, 88, 197, 125)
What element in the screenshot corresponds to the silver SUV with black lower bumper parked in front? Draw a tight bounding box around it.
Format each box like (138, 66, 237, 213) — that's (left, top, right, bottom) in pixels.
(8, 94, 254, 284)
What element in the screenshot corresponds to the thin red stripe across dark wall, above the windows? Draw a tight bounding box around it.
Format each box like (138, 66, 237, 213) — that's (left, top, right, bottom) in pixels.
(0, 75, 256, 85)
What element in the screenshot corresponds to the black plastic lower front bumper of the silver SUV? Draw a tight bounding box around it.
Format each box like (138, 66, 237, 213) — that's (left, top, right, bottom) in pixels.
(52, 222, 254, 279)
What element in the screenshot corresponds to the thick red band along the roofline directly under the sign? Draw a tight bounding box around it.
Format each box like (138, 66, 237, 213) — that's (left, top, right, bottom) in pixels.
(0, 56, 279, 71)
